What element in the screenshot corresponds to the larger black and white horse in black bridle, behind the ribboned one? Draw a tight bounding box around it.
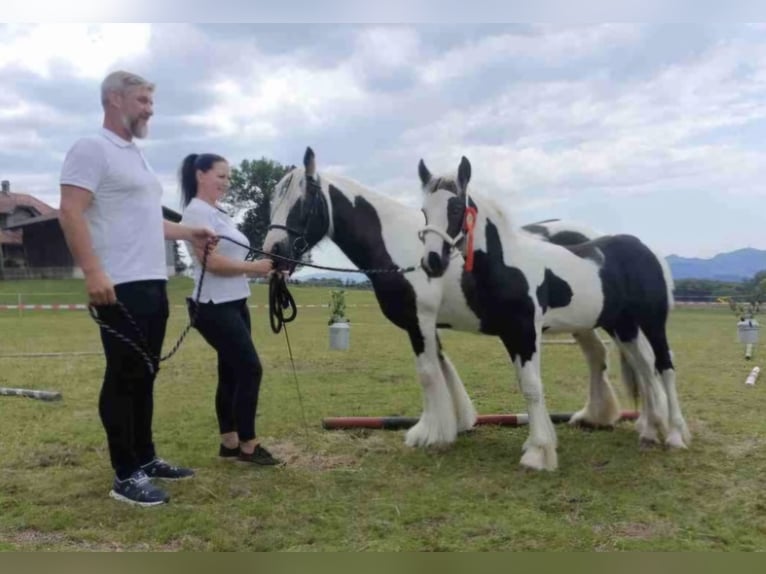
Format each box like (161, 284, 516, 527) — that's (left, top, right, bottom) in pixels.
(263, 148, 648, 468)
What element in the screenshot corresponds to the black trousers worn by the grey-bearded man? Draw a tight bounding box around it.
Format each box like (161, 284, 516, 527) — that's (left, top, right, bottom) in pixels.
(98, 280, 168, 479)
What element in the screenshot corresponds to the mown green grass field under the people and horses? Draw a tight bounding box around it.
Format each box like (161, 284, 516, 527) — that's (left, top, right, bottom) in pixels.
(0, 279, 766, 551)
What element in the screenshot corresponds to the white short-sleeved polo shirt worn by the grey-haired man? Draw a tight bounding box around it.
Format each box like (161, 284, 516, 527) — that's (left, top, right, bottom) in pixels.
(61, 129, 168, 285)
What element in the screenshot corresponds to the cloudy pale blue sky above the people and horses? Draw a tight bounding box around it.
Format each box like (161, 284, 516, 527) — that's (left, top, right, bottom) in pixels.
(0, 23, 766, 265)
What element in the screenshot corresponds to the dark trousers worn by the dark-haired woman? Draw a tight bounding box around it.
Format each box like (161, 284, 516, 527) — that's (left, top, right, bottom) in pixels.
(189, 299, 263, 442)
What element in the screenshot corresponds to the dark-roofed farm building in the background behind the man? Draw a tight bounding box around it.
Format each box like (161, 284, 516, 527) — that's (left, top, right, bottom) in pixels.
(0, 181, 181, 280)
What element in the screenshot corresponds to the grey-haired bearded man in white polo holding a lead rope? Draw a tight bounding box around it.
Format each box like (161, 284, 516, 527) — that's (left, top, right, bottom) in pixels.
(59, 71, 215, 506)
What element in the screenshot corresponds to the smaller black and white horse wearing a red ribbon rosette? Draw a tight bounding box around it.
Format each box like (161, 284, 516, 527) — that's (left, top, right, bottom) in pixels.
(419, 157, 690, 469)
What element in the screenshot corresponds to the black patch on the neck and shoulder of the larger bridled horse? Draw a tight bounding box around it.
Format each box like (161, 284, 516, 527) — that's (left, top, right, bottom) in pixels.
(329, 184, 425, 355)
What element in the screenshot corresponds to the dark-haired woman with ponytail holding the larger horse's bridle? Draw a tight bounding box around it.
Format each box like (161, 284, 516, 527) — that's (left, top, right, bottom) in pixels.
(181, 153, 280, 465)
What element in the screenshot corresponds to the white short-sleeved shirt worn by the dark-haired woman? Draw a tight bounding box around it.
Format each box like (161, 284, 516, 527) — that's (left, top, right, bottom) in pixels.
(181, 197, 250, 303)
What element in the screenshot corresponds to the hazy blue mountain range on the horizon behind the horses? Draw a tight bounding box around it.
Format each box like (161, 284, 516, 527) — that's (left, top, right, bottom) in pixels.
(296, 247, 766, 283)
